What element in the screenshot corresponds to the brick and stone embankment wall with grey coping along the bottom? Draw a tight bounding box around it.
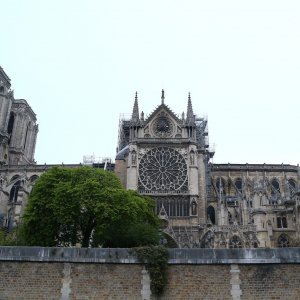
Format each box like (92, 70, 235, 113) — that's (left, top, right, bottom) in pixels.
(0, 247, 300, 300)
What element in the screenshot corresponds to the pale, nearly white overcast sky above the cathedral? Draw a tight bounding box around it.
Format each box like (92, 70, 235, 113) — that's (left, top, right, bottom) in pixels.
(0, 0, 300, 164)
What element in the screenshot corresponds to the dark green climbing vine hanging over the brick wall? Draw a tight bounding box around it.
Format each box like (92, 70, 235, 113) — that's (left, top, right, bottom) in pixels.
(134, 246, 169, 296)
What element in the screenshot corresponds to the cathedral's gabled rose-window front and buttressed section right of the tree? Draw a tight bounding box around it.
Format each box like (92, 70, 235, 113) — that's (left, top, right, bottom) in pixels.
(115, 91, 300, 248)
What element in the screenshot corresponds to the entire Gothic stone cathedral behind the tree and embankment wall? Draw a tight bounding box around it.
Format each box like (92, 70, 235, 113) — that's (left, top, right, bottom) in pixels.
(0, 67, 300, 248)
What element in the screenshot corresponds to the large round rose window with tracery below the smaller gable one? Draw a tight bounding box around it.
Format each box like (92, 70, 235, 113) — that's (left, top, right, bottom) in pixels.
(139, 147, 188, 193)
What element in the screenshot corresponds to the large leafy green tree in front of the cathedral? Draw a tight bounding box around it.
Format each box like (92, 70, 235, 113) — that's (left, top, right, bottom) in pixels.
(20, 167, 159, 247)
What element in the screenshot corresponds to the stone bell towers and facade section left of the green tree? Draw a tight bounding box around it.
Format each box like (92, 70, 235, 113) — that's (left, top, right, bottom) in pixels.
(0, 67, 38, 228)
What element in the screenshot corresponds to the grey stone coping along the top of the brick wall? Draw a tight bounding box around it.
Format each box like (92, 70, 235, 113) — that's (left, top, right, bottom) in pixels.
(0, 246, 300, 265)
